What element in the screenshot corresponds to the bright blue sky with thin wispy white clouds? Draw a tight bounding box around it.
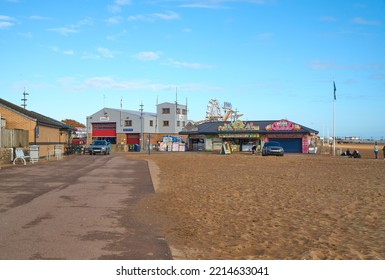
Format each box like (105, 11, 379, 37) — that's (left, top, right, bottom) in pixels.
(0, 0, 385, 138)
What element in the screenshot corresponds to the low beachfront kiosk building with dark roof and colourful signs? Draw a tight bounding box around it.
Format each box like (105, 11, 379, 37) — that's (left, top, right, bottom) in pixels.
(179, 119, 318, 154)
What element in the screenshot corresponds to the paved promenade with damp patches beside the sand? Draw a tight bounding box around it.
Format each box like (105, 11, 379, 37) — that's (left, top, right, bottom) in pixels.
(0, 154, 172, 260)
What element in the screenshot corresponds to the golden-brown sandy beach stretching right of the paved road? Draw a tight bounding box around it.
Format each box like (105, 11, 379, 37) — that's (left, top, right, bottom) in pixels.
(127, 146, 385, 260)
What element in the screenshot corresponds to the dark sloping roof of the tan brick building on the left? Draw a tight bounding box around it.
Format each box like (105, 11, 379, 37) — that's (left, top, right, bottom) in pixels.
(0, 98, 76, 130)
